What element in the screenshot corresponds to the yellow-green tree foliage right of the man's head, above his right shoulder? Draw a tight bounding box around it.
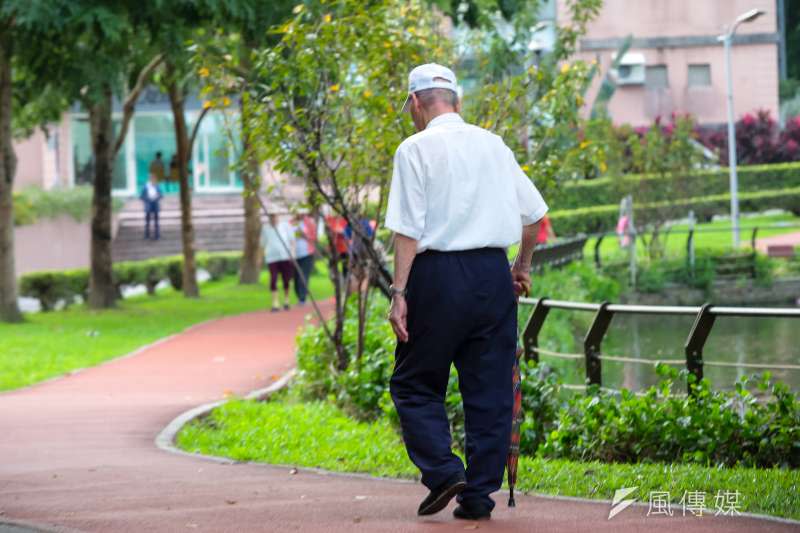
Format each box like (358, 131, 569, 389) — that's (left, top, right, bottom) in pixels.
(459, 0, 606, 191)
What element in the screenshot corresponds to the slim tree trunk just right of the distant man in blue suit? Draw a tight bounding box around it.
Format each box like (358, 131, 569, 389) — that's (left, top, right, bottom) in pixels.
(168, 77, 200, 298)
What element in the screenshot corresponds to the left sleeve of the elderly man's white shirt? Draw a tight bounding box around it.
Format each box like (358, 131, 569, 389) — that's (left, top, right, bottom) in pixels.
(385, 144, 427, 240)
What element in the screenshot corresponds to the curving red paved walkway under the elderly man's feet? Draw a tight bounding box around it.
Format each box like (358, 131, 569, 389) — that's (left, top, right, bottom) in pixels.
(0, 302, 798, 533)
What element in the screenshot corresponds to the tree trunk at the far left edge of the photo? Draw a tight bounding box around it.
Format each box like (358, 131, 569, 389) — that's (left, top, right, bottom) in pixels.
(0, 32, 22, 322)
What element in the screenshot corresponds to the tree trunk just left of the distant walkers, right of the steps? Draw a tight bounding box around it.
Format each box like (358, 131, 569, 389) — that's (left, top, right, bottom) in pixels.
(239, 50, 261, 284)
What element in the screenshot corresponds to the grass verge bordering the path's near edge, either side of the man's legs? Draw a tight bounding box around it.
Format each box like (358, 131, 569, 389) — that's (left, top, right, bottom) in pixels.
(177, 400, 800, 519)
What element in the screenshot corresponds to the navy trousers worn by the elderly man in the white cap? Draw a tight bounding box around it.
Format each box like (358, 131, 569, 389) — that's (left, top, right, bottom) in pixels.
(390, 248, 517, 510)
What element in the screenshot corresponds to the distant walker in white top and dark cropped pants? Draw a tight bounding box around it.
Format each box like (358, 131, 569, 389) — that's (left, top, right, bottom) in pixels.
(261, 213, 294, 313)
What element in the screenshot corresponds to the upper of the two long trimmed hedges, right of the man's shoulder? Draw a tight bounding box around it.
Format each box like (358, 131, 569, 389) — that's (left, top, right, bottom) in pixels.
(548, 163, 800, 211)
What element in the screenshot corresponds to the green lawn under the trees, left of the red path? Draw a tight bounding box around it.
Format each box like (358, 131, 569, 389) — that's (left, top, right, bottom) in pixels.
(0, 268, 333, 390)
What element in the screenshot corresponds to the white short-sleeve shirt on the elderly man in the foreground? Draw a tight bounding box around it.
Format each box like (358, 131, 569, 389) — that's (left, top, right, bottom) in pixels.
(386, 113, 547, 253)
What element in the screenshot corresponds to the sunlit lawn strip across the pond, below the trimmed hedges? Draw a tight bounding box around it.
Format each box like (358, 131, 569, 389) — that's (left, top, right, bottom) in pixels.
(584, 214, 800, 259)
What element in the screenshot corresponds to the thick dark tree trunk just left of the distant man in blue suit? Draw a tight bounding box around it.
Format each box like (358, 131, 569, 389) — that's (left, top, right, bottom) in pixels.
(87, 84, 117, 309)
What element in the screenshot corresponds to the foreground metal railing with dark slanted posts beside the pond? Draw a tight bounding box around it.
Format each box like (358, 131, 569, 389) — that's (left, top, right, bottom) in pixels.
(519, 298, 800, 394)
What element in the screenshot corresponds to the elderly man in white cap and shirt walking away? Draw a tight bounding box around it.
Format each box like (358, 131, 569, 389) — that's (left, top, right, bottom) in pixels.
(386, 64, 547, 520)
